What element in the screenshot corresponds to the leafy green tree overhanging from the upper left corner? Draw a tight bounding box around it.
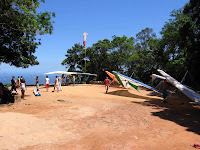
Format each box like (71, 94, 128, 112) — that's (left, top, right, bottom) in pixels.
(0, 0, 55, 68)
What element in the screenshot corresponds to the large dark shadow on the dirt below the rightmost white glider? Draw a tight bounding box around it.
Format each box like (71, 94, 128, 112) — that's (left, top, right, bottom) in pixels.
(132, 93, 200, 135)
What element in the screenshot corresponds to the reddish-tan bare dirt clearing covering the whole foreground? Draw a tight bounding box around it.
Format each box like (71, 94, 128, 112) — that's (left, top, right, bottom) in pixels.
(0, 85, 200, 150)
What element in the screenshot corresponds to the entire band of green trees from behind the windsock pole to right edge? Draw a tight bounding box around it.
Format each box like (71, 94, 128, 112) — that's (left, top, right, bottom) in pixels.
(62, 0, 200, 90)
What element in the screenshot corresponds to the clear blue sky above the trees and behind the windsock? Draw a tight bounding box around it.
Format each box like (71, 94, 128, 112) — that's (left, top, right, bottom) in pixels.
(0, 0, 189, 75)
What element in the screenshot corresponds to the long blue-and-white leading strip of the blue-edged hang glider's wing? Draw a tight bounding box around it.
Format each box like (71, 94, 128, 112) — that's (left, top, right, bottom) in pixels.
(113, 71, 160, 93)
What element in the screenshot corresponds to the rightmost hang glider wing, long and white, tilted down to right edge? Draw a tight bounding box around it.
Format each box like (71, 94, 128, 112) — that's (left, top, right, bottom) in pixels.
(158, 69, 200, 104)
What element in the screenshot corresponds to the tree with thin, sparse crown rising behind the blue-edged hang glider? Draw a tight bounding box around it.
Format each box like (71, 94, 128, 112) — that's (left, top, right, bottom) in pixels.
(127, 28, 156, 82)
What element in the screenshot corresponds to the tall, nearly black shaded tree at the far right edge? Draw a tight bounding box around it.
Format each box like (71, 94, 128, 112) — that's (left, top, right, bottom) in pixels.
(183, 0, 200, 90)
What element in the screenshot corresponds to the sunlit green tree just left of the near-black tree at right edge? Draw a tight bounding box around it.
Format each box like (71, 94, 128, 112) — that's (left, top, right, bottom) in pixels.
(161, 9, 188, 79)
